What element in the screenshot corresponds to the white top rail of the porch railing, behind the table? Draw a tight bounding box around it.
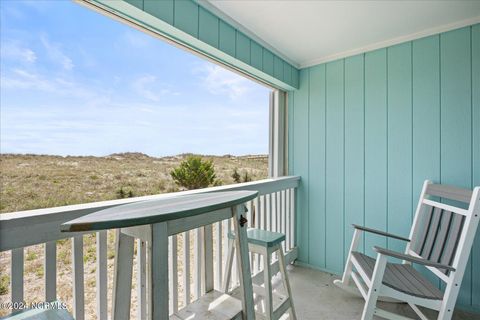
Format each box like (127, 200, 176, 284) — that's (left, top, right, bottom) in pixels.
(0, 176, 300, 251)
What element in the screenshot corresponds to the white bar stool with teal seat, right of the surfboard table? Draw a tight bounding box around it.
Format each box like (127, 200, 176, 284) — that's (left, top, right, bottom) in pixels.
(222, 229, 296, 320)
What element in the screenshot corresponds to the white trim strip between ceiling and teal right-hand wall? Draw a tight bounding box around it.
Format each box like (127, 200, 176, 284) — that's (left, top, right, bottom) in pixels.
(299, 16, 480, 69)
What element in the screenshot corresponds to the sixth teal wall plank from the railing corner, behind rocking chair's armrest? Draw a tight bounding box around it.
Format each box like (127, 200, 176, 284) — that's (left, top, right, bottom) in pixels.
(387, 43, 413, 251)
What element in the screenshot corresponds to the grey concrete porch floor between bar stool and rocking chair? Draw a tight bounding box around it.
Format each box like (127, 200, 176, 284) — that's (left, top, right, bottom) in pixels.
(288, 266, 480, 320)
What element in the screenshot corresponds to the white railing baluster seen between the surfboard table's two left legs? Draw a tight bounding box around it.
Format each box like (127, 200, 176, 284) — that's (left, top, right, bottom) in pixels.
(137, 239, 147, 320)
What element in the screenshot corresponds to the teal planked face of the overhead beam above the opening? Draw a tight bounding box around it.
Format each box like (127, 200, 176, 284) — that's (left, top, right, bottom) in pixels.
(121, 0, 299, 88)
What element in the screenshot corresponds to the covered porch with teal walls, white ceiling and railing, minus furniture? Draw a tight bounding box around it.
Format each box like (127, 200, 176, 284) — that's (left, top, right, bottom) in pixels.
(0, 0, 480, 320)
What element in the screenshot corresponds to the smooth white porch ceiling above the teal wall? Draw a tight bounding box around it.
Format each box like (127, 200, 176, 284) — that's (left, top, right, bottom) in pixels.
(200, 0, 480, 67)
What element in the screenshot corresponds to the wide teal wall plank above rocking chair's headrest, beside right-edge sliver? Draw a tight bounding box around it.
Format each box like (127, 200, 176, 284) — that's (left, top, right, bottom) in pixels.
(440, 28, 472, 304)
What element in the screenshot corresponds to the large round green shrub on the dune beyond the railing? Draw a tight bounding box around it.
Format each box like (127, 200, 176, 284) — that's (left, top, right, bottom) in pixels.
(170, 156, 216, 190)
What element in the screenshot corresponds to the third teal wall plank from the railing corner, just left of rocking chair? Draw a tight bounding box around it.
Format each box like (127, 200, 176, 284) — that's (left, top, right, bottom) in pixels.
(325, 60, 344, 270)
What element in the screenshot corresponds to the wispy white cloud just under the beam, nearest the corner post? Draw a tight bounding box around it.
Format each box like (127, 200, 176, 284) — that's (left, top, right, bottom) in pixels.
(198, 64, 250, 99)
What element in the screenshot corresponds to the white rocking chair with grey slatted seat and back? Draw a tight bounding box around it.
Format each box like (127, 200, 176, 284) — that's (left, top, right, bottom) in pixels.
(335, 180, 480, 320)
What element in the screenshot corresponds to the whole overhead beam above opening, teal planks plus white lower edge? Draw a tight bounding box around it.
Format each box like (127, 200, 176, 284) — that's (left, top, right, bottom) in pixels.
(88, 0, 299, 90)
